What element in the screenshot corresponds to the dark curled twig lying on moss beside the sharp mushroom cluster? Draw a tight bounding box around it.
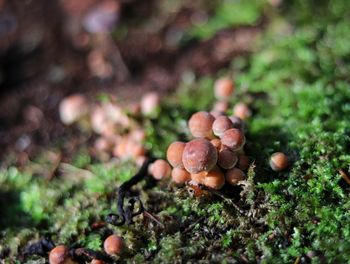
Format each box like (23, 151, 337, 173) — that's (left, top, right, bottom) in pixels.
(106, 158, 155, 226)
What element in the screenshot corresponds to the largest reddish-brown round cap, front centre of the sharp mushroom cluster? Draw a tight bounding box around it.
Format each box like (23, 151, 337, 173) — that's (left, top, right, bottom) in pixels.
(182, 138, 218, 173)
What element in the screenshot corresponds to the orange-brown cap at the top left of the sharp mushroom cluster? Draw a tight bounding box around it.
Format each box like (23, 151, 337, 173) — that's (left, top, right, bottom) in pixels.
(188, 111, 215, 138)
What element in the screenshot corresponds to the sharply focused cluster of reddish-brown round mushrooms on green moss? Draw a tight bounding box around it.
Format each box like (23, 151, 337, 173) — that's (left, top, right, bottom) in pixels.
(167, 111, 249, 190)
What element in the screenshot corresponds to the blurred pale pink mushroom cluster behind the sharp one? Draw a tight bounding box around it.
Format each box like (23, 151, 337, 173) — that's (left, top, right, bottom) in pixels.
(59, 92, 160, 164)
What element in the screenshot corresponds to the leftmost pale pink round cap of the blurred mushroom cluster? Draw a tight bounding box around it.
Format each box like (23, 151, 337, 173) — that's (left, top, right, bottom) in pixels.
(59, 94, 88, 125)
